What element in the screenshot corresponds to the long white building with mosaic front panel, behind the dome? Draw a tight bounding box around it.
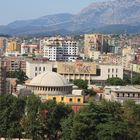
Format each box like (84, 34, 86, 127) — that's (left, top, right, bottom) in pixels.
(26, 60, 123, 84)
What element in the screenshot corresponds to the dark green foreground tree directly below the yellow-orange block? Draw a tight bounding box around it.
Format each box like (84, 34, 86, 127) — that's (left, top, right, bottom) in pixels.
(38, 100, 73, 140)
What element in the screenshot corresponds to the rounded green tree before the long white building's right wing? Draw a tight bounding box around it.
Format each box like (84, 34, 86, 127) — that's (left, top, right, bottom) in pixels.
(106, 77, 124, 86)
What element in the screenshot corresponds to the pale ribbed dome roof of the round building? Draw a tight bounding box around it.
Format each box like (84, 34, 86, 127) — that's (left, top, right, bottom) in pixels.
(28, 72, 70, 87)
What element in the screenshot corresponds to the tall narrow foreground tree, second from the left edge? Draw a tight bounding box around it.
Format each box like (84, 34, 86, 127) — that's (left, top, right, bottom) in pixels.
(21, 95, 41, 140)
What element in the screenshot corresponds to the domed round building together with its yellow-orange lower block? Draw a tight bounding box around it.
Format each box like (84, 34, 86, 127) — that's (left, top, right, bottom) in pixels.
(26, 72, 84, 104)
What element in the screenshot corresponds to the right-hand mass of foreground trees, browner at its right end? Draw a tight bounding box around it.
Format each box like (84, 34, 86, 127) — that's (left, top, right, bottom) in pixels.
(61, 101, 140, 140)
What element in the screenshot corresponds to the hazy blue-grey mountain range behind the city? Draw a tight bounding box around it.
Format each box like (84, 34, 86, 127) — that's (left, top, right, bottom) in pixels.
(0, 0, 140, 35)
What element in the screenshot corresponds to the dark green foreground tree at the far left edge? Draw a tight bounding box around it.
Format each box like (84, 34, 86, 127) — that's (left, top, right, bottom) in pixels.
(0, 94, 25, 138)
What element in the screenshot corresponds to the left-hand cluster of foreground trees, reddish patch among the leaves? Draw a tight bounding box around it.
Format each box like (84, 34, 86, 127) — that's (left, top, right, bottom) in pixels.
(0, 95, 73, 140)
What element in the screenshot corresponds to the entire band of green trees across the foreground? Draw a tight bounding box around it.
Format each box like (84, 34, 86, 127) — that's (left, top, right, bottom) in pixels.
(0, 95, 140, 140)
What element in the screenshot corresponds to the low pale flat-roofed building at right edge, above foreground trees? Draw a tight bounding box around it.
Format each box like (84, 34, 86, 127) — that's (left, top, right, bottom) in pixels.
(103, 86, 140, 103)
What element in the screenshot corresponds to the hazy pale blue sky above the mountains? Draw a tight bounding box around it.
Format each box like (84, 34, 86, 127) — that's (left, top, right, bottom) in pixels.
(0, 0, 107, 25)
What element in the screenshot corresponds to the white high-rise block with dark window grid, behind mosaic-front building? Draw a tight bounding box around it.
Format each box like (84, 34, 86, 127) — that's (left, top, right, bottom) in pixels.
(40, 37, 78, 61)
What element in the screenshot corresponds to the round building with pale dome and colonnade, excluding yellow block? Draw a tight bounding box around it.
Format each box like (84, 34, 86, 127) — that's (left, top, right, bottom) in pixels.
(26, 72, 72, 100)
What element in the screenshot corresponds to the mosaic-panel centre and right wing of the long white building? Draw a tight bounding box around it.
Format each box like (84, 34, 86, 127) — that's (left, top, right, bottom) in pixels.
(57, 61, 123, 84)
